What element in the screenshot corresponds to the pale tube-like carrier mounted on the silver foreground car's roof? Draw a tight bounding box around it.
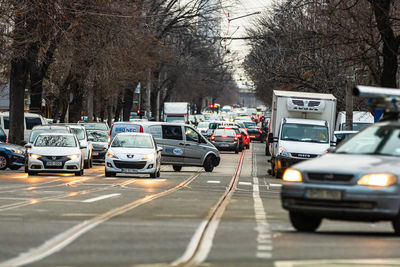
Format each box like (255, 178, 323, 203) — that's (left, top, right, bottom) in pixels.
(353, 85, 400, 121)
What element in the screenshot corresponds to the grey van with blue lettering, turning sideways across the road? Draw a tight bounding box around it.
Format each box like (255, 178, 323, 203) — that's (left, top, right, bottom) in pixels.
(109, 122, 220, 172)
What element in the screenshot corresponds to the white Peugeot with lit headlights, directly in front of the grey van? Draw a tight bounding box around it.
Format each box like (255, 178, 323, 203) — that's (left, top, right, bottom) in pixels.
(105, 133, 162, 178)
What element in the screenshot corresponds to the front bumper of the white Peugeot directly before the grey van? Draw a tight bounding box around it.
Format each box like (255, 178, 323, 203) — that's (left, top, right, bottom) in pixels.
(105, 157, 157, 174)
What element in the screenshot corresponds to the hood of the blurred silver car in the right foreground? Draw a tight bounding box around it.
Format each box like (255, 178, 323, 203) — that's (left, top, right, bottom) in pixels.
(293, 153, 400, 174)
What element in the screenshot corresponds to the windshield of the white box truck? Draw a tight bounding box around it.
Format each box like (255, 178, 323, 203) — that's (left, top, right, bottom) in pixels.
(281, 123, 329, 143)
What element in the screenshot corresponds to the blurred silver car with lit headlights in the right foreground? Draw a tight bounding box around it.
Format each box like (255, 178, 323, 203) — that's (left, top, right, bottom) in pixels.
(281, 121, 400, 235)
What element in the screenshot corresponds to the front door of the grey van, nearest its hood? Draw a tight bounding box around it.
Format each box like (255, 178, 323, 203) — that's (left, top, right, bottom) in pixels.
(184, 126, 207, 165)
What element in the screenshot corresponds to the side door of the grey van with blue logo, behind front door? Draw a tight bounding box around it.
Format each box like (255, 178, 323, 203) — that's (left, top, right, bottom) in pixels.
(159, 125, 185, 165)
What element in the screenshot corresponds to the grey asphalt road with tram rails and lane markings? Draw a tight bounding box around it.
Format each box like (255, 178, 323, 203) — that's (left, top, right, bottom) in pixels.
(0, 143, 400, 267)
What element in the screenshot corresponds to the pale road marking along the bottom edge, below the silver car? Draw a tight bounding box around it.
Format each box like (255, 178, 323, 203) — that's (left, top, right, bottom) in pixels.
(274, 258, 400, 267)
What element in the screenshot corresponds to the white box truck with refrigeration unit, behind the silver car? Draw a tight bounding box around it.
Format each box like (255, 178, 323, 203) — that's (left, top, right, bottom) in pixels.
(267, 90, 336, 178)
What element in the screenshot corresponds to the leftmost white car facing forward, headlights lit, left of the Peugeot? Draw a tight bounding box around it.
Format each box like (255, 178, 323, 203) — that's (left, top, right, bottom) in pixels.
(26, 133, 84, 176)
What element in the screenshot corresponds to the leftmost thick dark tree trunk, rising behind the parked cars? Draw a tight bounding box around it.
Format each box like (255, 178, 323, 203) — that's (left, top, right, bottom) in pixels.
(8, 57, 28, 144)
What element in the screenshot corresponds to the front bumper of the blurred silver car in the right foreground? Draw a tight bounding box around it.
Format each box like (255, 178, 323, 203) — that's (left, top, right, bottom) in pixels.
(281, 183, 400, 221)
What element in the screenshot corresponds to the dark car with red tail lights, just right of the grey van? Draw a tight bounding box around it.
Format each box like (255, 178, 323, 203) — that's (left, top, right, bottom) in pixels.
(211, 129, 240, 154)
